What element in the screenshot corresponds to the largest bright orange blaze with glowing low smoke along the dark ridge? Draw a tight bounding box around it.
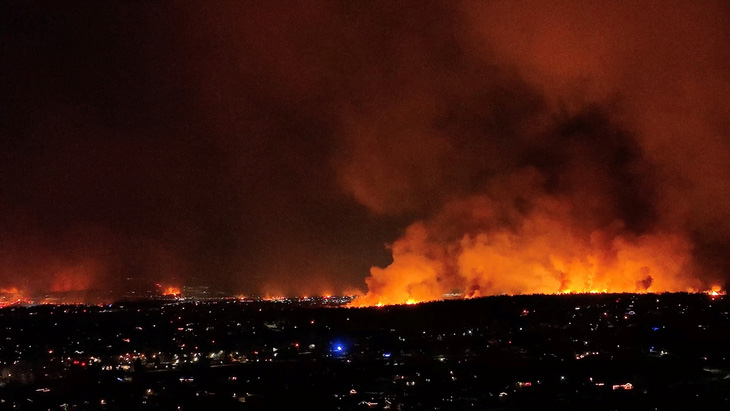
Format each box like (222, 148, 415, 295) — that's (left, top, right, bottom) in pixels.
(351, 183, 721, 307)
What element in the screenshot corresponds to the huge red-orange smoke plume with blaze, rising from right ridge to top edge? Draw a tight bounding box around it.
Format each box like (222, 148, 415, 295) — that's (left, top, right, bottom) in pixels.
(340, 1, 730, 305)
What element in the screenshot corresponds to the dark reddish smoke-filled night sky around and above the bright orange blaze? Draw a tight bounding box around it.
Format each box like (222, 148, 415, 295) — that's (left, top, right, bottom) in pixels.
(0, 1, 730, 300)
